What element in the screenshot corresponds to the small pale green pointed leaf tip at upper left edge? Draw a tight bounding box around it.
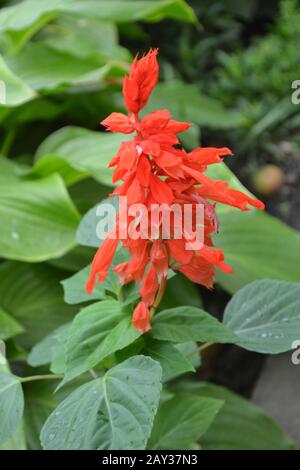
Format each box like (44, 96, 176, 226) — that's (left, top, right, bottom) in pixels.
(0, 56, 35, 106)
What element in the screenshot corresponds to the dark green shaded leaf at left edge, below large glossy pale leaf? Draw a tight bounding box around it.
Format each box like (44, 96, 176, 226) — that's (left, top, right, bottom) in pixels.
(0, 262, 76, 348)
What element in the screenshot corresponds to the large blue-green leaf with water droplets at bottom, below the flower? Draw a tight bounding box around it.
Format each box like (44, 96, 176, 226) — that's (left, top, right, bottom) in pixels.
(41, 356, 161, 450)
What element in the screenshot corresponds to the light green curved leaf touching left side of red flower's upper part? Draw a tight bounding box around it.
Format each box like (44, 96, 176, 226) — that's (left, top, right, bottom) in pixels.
(36, 127, 126, 186)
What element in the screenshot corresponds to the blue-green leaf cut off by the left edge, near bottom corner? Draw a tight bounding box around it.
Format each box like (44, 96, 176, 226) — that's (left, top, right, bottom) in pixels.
(0, 372, 24, 444)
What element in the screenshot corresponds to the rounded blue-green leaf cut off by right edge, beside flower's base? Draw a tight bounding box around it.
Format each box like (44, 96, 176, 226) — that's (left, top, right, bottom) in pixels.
(224, 280, 300, 354)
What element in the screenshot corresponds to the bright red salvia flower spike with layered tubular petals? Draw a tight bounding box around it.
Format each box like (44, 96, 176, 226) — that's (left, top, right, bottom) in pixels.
(86, 49, 264, 333)
